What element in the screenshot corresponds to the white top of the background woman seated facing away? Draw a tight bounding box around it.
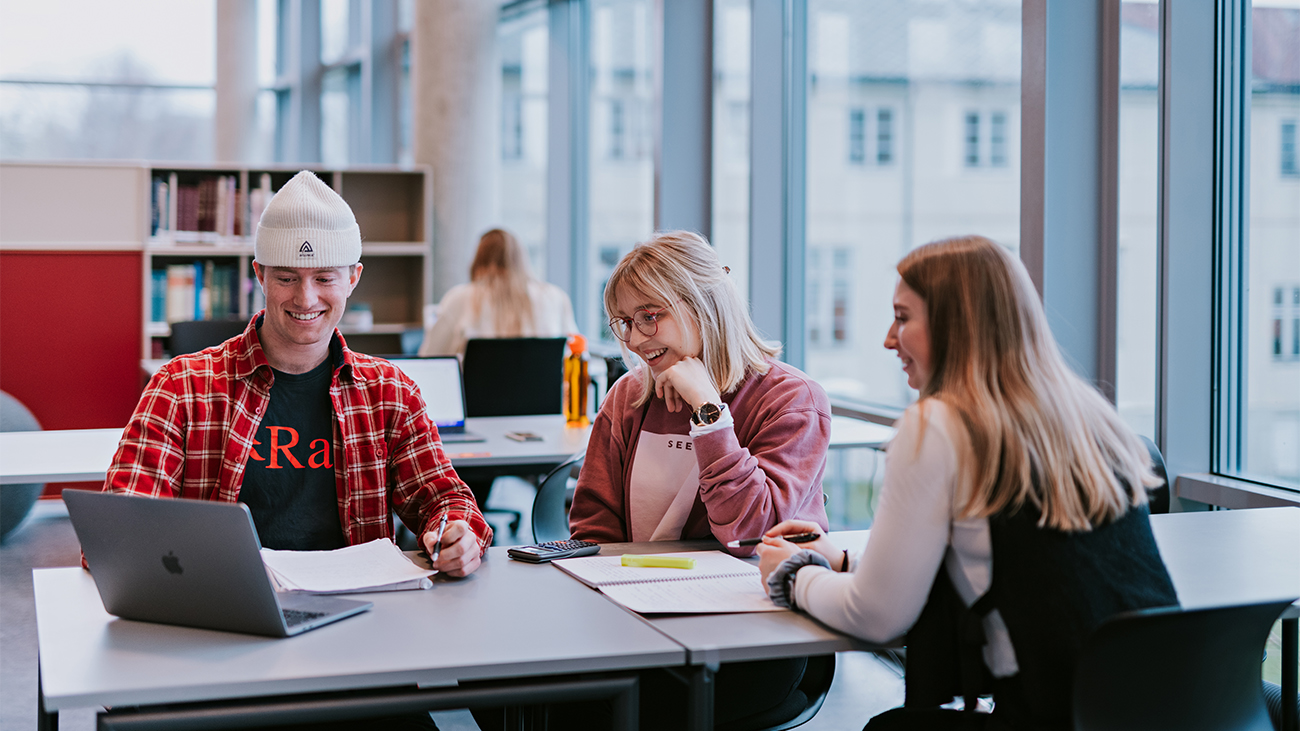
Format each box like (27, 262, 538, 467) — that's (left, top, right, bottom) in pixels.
(420, 280, 579, 355)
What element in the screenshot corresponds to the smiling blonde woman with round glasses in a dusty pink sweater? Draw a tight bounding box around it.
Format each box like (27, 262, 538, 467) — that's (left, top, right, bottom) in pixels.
(564, 232, 831, 728)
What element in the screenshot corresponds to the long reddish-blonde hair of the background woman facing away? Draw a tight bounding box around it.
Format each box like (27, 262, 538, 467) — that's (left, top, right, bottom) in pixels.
(469, 229, 533, 338)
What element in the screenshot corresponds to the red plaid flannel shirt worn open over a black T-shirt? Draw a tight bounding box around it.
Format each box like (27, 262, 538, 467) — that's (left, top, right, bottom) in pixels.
(104, 313, 491, 550)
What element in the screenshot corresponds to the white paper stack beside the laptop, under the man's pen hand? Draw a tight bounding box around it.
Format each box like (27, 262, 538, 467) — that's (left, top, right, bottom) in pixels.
(261, 538, 434, 594)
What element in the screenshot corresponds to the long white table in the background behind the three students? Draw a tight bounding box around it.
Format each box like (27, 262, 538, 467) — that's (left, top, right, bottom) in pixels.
(0, 415, 893, 485)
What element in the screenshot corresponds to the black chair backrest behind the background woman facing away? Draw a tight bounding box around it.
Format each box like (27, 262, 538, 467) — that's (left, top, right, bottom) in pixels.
(464, 338, 566, 418)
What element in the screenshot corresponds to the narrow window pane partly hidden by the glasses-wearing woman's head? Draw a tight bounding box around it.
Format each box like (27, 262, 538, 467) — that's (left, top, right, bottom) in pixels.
(585, 0, 657, 342)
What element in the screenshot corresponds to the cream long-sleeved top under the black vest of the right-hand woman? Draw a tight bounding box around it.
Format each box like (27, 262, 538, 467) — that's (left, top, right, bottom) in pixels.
(794, 399, 1018, 678)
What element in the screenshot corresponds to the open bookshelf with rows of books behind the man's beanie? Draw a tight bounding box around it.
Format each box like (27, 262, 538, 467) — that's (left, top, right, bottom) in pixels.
(142, 165, 433, 358)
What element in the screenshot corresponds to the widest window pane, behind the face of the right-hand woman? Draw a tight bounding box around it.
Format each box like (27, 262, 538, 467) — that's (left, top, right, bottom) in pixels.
(802, 0, 1021, 407)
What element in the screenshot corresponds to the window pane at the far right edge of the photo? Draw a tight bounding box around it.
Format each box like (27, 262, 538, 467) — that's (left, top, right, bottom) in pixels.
(1237, 3, 1300, 488)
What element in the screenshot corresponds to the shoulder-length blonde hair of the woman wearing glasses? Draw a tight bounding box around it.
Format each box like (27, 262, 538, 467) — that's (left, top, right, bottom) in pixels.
(605, 232, 781, 406)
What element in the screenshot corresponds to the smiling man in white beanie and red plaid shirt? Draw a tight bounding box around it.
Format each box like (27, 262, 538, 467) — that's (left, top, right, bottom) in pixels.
(104, 170, 491, 598)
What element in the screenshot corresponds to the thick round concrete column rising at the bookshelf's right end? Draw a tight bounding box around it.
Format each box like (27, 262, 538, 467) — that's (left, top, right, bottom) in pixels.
(411, 0, 501, 299)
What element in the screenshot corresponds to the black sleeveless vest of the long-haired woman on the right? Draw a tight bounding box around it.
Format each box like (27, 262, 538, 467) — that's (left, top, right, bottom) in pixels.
(905, 496, 1178, 728)
